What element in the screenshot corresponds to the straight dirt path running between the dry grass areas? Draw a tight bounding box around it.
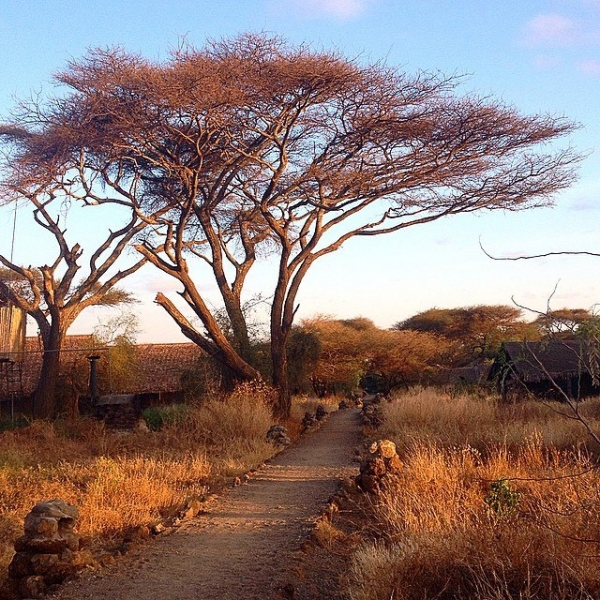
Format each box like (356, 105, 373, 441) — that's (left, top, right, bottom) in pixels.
(53, 410, 359, 600)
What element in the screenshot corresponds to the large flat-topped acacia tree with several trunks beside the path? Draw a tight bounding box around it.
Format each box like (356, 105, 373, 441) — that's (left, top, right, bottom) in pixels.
(1, 35, 577, 413)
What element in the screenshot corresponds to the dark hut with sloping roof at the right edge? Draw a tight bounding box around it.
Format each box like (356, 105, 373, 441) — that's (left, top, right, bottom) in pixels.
(488, 340, 600, 401)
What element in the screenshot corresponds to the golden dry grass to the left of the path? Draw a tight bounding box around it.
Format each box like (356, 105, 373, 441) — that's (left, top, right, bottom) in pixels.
(0, 394, 298, 581)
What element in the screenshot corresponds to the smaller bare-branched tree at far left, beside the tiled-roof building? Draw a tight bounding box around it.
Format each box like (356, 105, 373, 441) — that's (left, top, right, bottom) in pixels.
(0, 196, 146, 418)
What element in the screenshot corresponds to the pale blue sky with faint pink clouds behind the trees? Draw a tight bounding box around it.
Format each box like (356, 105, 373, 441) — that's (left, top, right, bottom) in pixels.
(0, 0, 600, 342)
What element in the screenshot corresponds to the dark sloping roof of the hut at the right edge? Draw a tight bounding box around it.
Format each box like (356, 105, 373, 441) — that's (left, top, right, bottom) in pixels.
(490, 340, 589, 383)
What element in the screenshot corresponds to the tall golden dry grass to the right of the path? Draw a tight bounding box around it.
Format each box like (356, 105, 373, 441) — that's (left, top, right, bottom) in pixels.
(348, 390, 600, 600)
